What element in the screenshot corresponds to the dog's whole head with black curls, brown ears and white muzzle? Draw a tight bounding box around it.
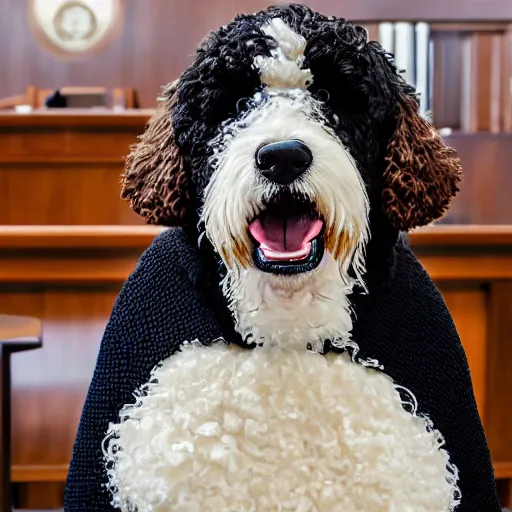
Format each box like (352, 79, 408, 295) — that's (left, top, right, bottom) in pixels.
(123, 6, 460, 284)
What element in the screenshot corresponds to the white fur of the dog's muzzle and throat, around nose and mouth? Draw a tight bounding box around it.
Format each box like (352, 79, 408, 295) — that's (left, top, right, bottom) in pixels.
(202, 91, 369, 349)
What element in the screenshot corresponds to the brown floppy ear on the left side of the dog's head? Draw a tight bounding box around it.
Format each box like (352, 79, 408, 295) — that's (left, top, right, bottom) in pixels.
(121, 81, 192, 226)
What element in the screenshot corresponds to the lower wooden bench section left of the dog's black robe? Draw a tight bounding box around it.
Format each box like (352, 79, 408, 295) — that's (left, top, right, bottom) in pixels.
(0, 226, 160, 509)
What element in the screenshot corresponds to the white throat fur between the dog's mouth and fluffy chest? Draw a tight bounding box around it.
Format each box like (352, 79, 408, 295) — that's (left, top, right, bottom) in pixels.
(223, 253, 355, 352)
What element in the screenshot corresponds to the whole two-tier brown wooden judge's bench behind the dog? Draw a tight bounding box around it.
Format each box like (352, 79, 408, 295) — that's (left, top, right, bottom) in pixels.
(0, 110, 512, 508)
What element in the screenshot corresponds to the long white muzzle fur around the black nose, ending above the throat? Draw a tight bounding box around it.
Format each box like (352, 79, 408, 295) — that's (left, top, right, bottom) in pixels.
(202, 90, 370, 280)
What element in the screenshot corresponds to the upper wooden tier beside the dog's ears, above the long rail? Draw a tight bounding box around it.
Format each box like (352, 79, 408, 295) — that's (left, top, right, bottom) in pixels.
(0, 109, 512, 225)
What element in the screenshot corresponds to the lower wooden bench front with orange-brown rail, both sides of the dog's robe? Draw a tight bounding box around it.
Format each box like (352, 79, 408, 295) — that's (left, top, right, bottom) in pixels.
(0, 226, 512, 508)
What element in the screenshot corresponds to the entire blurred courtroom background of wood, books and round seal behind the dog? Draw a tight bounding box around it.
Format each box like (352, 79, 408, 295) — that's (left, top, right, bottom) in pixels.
(0, 0, 512, 510)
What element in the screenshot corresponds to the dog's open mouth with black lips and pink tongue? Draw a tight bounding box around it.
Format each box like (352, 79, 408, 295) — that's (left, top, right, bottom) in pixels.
(249, 195, 325, 274)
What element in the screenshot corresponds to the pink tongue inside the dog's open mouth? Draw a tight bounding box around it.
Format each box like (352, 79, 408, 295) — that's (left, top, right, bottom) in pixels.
(249, 215, 323, 260)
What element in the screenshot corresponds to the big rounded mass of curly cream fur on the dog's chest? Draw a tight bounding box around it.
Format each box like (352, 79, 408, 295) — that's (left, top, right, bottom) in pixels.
(106, 343, 454, 512)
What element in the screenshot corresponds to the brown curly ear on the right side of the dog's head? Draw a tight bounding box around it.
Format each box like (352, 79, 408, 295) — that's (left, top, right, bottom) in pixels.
(382, 97, 462, 231)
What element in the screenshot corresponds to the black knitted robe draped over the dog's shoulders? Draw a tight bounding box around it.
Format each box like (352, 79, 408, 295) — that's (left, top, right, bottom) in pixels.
(65, 229, 500, 512)
